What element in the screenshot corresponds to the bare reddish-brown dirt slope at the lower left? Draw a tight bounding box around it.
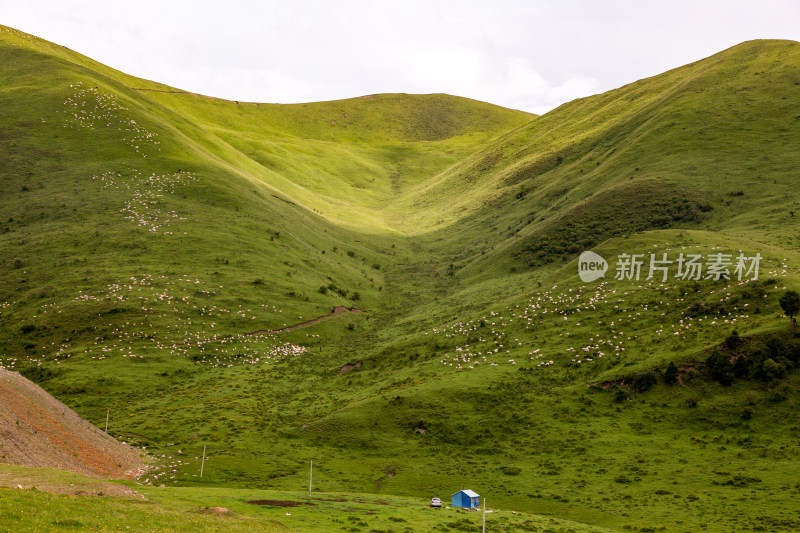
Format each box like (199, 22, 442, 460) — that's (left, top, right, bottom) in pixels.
(0, 368, 141, 479)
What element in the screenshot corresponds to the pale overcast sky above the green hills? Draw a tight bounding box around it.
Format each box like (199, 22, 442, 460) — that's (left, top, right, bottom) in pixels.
(0, 0, 800, 113)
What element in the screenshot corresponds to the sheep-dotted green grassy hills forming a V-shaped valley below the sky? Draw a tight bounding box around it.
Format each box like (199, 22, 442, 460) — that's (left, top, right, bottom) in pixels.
(0, 27, 800, 532)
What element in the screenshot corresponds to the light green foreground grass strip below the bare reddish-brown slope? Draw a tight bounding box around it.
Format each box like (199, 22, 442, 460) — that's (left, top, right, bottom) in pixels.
(0, 466, 620, 533)
